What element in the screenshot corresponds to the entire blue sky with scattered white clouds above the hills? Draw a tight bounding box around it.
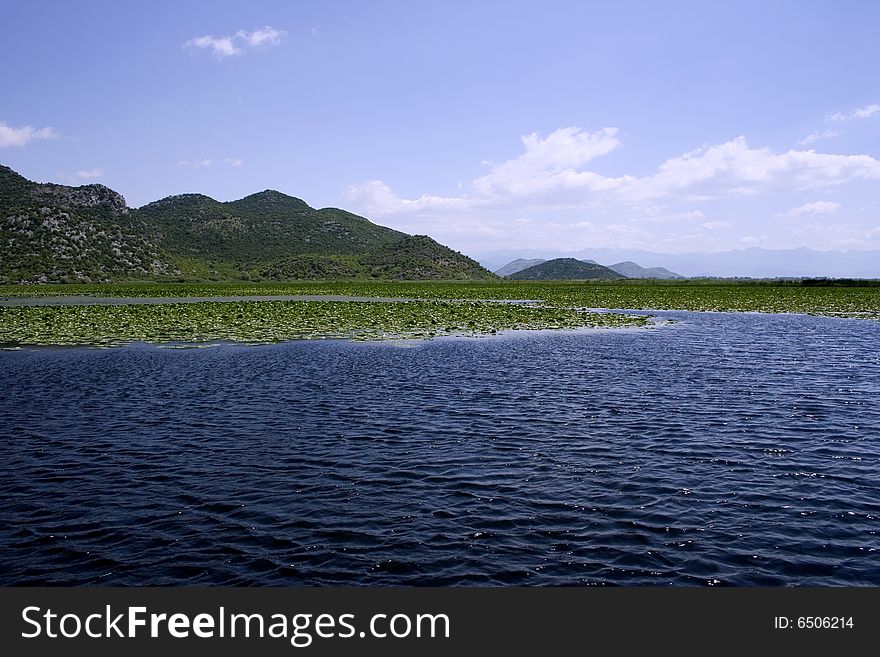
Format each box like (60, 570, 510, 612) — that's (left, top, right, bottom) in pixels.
(0, 0, 880, 256)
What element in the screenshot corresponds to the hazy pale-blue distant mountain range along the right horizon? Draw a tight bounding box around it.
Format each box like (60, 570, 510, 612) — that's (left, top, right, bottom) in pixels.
(476, 247, 880, 278)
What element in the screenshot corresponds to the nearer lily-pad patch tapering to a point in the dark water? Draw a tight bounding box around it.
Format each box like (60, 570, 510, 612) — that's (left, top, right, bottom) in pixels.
(0, 301, 647, 346)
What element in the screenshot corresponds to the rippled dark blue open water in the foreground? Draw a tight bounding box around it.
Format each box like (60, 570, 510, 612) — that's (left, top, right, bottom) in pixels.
(0, 313, 880, 586)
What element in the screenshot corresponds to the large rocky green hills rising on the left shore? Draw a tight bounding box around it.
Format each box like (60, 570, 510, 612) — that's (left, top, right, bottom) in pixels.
(0, 166, 495, 283)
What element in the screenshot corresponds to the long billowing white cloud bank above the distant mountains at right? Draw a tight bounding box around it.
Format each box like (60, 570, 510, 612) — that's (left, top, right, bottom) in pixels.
(345, 128, 880, 223)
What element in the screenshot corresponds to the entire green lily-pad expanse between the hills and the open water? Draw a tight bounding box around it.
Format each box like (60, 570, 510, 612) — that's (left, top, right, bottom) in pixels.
(0, 280, 880, 347)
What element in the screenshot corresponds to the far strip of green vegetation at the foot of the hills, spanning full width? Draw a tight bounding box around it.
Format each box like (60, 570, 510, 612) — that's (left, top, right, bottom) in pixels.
(0, 280, 880, 319)
